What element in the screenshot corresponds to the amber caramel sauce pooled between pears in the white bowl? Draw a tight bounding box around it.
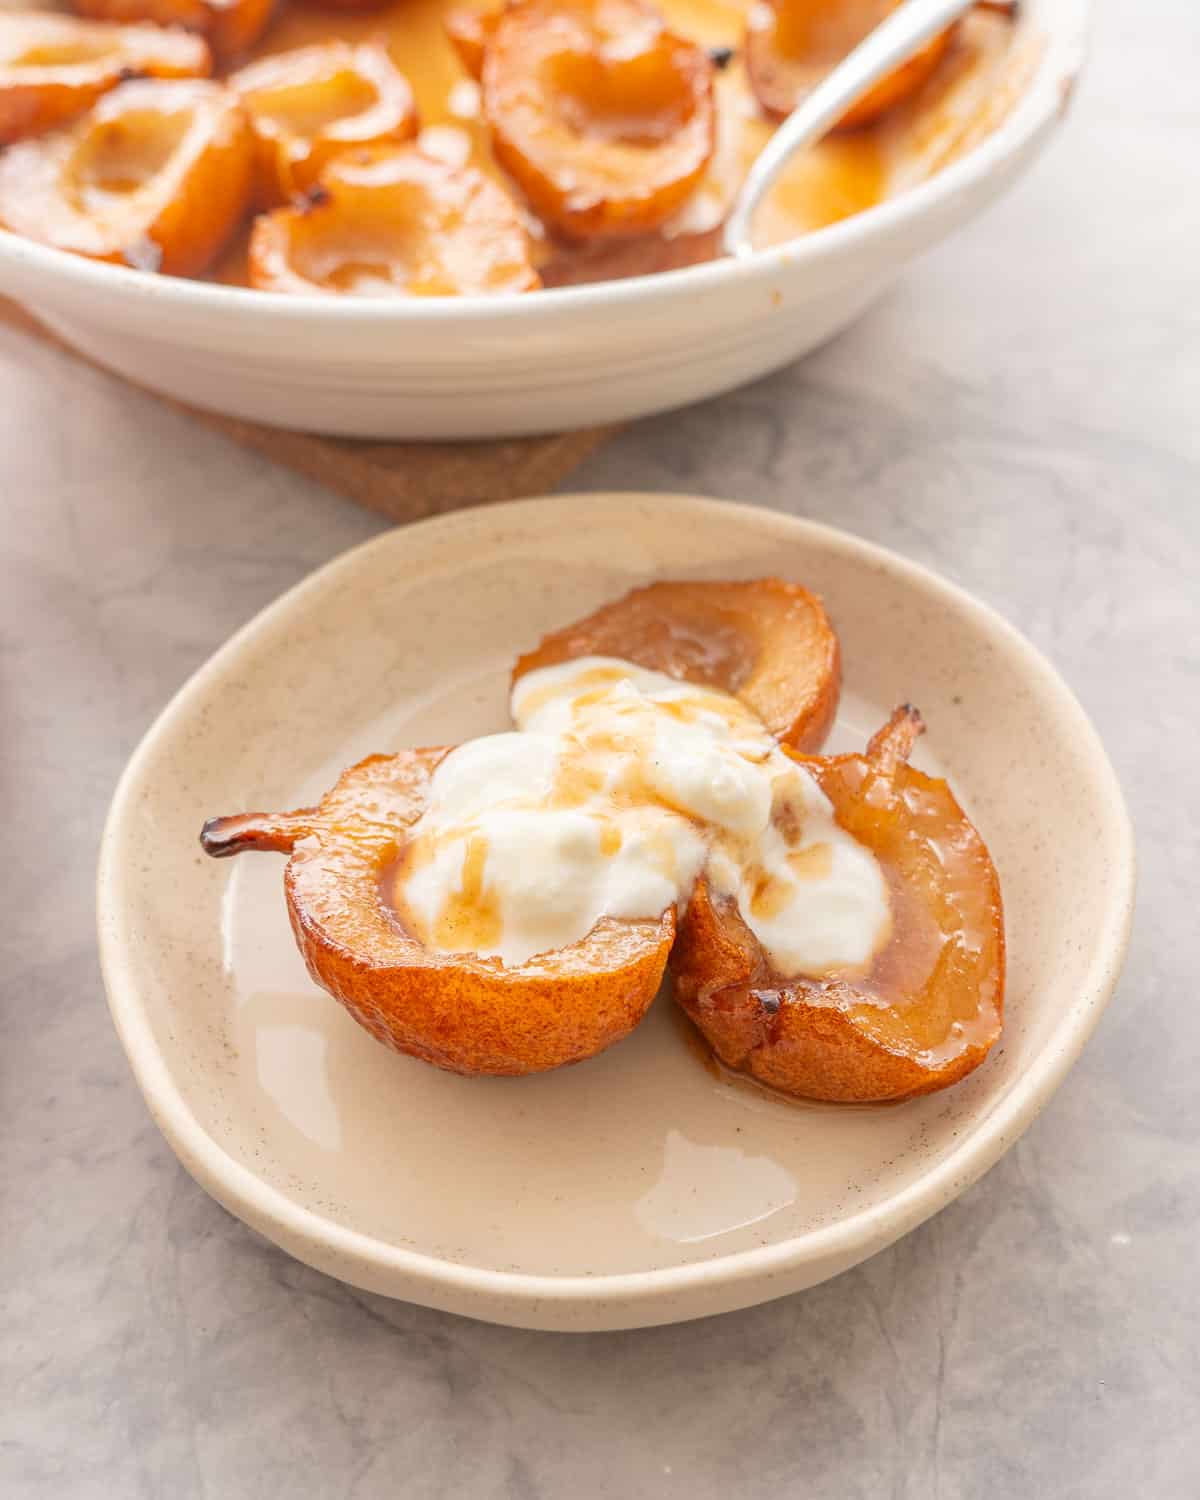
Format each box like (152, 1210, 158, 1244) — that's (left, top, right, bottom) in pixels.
(210, 0, 1020, 285)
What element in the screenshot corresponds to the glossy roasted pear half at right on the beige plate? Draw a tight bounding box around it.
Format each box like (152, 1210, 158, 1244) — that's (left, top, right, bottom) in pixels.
(671, 707, 1005, 1103)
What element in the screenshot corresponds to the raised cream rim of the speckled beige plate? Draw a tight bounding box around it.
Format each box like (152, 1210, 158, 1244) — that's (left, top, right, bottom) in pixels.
(96, 492, 1136, 1316)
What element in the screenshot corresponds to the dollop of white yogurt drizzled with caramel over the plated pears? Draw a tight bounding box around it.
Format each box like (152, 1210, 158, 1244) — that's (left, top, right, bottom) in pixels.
(395, 657, 891, 977)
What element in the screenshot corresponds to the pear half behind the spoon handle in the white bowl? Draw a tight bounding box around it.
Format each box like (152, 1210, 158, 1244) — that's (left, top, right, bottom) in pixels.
(746, 0, 951, 131)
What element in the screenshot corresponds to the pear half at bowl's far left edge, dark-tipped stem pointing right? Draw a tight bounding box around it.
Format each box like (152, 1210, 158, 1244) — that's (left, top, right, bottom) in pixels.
(0, 12, 212, 146)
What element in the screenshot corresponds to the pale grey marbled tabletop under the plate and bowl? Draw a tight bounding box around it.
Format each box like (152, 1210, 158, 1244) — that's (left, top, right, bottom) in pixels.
(0, 0, 1200, 1500)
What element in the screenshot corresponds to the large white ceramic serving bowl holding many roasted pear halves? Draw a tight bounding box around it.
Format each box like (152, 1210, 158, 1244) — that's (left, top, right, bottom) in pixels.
(0, 0, 1088, 440)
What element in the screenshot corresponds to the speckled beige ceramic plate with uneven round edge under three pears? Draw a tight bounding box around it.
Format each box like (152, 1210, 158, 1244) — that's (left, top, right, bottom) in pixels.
(99, 495, 1133, 1329)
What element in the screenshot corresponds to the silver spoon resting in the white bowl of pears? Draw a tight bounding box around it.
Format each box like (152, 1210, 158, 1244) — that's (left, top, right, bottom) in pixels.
(723, 0, 1010, 257)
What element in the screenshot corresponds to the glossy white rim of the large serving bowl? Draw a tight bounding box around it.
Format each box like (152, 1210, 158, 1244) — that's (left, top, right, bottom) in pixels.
(0, 0, 1092, 326)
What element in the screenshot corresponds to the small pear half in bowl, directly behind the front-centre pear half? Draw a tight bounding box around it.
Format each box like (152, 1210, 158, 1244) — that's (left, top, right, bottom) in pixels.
(230, 42, 417, 207)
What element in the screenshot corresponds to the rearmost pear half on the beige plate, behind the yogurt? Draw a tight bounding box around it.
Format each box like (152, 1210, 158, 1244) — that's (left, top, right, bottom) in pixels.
(513, 578, 842, 750)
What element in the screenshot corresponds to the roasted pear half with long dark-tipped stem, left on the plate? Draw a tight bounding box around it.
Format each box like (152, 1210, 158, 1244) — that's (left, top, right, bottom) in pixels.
(201, 749, 675, 1074)
